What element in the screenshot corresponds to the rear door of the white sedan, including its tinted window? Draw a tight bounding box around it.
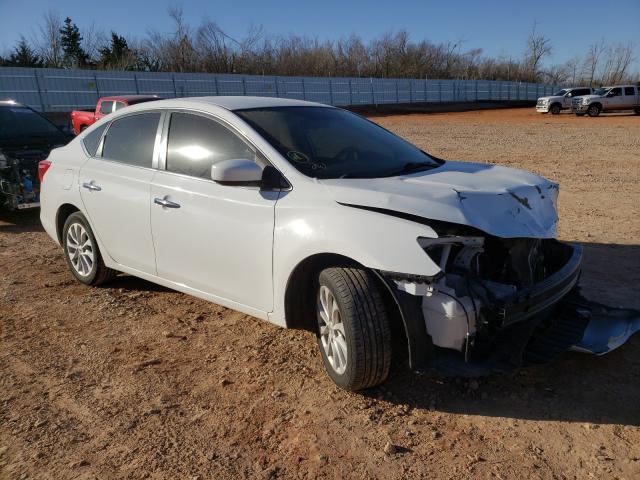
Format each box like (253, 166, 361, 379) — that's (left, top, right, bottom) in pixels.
(80, 111, 161, 274)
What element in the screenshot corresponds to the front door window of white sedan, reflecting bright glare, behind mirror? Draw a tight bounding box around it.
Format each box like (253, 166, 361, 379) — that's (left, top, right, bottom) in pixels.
(166, 113, 256, 179)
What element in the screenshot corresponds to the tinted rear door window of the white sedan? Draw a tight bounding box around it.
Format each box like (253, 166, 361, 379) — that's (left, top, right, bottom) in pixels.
(102, 112, 160, 168)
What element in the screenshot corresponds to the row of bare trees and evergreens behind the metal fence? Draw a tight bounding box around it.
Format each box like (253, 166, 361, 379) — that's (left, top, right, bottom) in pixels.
(0, 7, 640, 86)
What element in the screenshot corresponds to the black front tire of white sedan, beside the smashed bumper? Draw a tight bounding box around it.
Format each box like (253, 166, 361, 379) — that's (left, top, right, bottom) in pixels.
(315, 268, 391, 391)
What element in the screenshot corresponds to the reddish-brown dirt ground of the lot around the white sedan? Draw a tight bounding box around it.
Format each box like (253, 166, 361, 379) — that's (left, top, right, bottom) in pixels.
(0, 109, 640, 480)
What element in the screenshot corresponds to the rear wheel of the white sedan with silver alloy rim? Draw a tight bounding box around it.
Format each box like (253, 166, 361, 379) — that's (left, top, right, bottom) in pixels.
(62, 212, 117, 285)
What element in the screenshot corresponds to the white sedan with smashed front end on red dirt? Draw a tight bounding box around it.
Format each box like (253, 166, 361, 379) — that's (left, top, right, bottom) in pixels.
(41, 97, 640, 390)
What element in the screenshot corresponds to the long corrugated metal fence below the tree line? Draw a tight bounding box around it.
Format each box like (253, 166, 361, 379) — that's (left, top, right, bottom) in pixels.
(0, 67, 557, 112)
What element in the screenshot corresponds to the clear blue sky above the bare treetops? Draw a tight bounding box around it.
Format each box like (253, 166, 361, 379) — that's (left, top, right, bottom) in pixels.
(0, 0, 640, 70)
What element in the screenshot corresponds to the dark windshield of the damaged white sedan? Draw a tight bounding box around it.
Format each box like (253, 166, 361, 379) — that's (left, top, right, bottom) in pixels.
(235, 107, 442, 179)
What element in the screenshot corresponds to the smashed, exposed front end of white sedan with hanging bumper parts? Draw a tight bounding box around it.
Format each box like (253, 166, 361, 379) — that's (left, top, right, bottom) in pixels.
(388, 232, 640, 375)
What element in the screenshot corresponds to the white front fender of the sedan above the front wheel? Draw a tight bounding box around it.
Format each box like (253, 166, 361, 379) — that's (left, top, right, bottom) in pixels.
(269, 184, 440, 326)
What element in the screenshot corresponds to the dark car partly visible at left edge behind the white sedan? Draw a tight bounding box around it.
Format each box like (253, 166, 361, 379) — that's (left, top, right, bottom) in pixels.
(0, 100, 73, 210)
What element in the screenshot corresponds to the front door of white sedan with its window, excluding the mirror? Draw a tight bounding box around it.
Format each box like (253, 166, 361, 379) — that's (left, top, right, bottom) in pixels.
(151, 112, 279, 312)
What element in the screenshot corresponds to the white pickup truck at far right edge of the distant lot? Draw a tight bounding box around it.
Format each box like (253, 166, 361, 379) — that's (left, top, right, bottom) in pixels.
(571, 85, 640, 117)
